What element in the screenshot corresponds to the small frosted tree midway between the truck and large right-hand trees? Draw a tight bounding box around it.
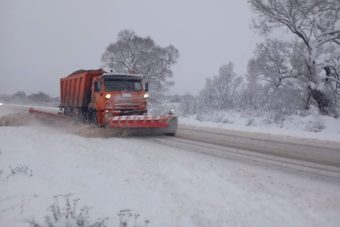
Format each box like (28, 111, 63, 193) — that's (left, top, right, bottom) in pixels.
(199, 63, 242, 110)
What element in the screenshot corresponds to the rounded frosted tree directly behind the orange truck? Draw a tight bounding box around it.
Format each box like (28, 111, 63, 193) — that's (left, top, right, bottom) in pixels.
(102, 30, 179, 98)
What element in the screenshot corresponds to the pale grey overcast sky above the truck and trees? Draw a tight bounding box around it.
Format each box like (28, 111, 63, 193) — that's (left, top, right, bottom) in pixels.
(0, 0, 259, 96)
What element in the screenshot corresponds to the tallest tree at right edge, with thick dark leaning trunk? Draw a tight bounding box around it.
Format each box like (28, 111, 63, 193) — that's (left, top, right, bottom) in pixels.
(249, 0, 340, 116)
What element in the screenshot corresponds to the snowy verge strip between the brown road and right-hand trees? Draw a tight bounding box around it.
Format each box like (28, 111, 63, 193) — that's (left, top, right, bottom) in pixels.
(180, 110, 340, 142)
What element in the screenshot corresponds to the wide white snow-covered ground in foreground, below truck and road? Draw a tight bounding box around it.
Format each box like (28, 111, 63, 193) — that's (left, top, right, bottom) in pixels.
(0, 108, 340, 227)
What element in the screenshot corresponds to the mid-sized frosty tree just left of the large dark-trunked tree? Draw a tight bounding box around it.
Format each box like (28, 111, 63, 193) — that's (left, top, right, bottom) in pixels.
(246, 39, 308, 119)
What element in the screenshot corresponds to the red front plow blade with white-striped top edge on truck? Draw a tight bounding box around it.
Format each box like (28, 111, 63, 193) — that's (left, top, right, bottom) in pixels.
(106, 115, 177, 135)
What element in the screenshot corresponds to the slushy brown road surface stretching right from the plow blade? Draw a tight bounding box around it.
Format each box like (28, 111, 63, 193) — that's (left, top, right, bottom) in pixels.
(174, 125, 340, 177)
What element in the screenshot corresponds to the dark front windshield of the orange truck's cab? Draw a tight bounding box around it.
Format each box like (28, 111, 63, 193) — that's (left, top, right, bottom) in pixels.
(104, 80, 143, 91)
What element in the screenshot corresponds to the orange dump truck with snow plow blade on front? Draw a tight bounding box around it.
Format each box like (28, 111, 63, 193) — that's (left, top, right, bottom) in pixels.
(31, 69, 177, 135)
